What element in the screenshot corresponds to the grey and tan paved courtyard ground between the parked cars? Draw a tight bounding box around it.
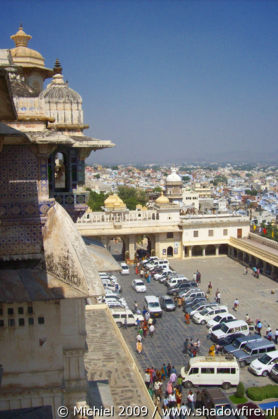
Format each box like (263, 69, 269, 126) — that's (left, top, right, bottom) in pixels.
(114, 256, 278, 394)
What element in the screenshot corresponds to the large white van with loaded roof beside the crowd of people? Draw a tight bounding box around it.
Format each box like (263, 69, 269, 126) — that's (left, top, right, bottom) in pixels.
(181, 355, 240, 389)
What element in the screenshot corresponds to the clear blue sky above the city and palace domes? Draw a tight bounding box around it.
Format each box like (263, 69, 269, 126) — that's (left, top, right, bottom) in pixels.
(0, 0, 278, 164)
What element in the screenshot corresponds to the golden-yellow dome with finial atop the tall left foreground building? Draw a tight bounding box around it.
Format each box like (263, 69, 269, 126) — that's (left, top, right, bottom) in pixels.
(11, 25, 45, 68)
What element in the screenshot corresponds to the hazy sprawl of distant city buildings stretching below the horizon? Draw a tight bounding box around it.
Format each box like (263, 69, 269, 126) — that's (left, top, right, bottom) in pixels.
(86, 163, 278, 225)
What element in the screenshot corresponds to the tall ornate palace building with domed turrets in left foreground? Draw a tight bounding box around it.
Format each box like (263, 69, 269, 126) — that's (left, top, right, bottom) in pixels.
(0, 27, 114, 418)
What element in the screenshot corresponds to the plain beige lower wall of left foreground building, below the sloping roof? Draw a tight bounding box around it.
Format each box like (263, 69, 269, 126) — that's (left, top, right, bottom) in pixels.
(0, 298, 86, 417)
